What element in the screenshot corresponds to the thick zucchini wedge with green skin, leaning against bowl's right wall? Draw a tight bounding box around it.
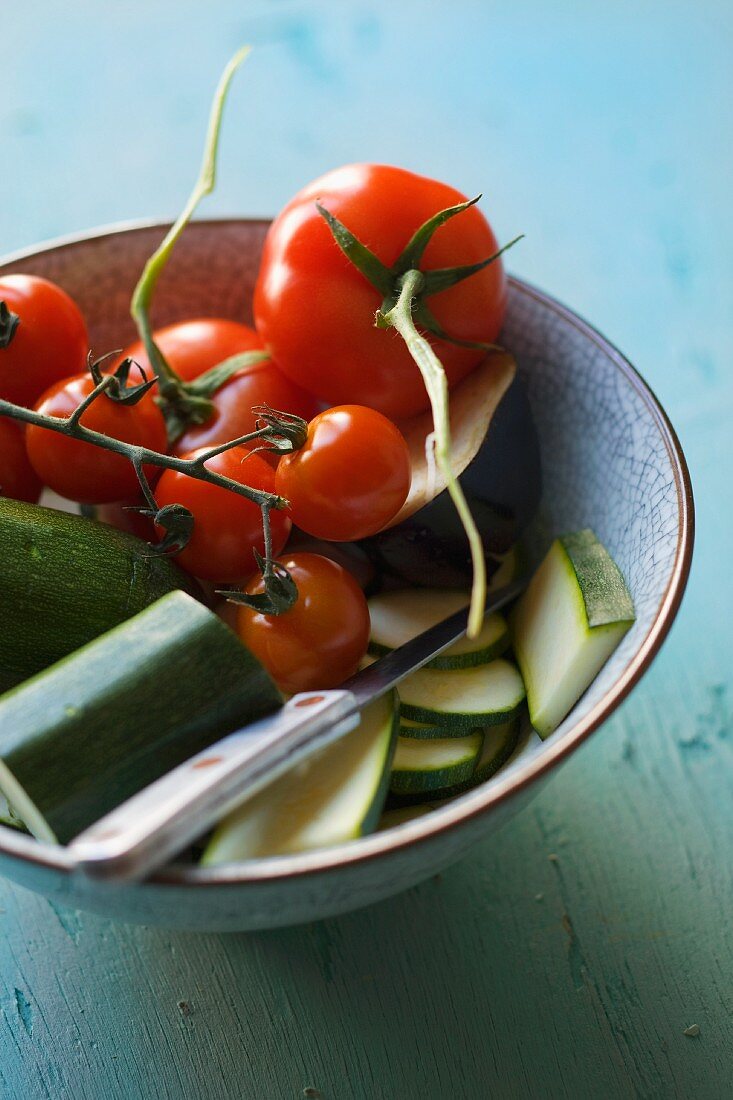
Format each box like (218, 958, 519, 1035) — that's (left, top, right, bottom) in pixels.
(512, 528, 634, 737)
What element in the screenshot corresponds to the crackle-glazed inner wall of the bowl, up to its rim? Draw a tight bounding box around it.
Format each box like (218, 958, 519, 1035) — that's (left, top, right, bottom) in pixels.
(0, 220, 692, 924)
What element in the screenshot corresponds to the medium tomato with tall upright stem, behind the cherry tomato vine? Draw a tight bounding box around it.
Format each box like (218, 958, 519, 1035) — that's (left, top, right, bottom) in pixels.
(120, 317, 318, 454)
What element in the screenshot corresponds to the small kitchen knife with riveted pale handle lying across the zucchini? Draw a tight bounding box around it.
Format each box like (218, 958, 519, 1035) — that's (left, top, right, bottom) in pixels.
(68, 579, 526, 881)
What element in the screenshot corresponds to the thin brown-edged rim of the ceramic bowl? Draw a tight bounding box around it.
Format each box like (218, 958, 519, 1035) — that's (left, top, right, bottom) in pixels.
(0, 218, 694, 889)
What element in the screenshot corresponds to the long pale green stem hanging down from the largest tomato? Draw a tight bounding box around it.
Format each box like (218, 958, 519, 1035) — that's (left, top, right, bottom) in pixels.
(381, 270, 486, 638)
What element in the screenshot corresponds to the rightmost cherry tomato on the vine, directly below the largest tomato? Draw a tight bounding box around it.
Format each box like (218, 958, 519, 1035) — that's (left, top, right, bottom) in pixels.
(275, 405, 411, 542)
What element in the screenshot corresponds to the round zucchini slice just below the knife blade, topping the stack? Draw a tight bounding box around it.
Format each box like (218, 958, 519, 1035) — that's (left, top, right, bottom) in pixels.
(400, 658, 525, 736)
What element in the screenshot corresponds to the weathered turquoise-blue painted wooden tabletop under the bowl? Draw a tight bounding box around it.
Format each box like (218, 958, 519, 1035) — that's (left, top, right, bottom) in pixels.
(0, 0, 733, 1100)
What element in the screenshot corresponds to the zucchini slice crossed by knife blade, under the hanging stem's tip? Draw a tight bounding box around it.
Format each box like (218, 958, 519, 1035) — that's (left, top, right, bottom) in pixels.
(369, 589, 510, 669)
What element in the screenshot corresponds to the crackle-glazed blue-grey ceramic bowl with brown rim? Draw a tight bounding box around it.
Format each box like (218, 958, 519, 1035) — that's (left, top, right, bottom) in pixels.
(0, 220, 693, 931)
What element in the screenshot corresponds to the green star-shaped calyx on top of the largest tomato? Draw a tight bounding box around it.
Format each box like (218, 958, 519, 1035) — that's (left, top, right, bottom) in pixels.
(316, 195, 523, 351)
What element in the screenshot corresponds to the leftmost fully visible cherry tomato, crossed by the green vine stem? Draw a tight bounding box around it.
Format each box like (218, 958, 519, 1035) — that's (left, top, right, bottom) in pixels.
(25, 374, 167, 504)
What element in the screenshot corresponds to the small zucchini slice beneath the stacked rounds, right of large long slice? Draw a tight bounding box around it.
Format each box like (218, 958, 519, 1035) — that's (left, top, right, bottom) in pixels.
(390, 729, 484, 798)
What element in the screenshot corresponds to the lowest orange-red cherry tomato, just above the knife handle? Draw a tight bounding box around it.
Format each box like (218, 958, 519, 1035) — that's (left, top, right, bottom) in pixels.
(237, 553, 370, 692)
